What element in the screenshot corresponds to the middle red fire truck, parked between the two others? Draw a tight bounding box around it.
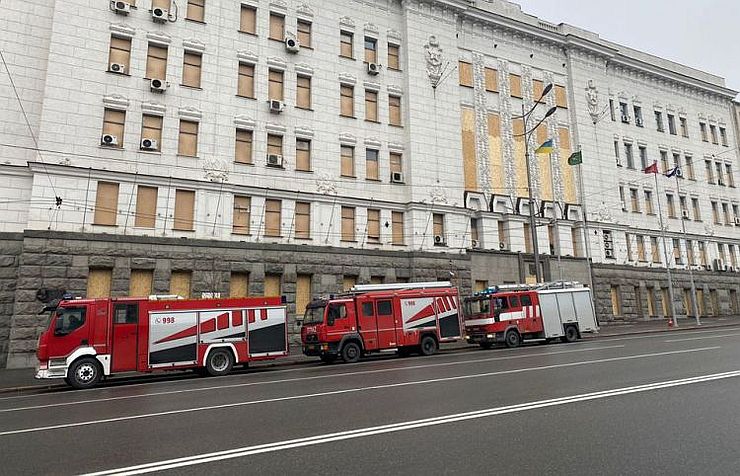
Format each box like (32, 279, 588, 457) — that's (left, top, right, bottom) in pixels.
(301, 282, 462, 362)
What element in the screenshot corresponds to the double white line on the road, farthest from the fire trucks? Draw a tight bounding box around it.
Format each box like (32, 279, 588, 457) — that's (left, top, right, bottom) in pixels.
(88, 370, 740, 476)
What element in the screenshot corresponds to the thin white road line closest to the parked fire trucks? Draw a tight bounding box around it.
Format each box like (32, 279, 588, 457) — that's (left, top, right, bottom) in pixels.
(0, 345, 625, 413)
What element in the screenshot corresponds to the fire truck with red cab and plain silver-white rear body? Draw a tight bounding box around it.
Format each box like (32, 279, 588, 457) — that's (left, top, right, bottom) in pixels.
(464, 282, 599, 349)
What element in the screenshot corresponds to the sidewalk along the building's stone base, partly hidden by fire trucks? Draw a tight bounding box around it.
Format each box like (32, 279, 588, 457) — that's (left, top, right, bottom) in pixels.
(0, 316, 740, 397)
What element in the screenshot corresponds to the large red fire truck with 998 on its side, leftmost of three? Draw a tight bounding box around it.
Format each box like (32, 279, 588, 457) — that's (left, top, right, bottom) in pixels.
(36, 296, 288, 388)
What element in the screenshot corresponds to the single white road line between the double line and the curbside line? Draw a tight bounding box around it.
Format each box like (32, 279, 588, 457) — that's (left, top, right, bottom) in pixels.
(0, 346, 721, 436)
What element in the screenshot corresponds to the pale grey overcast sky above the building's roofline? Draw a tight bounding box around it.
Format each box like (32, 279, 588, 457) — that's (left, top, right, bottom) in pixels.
(513, 0, 740, 95)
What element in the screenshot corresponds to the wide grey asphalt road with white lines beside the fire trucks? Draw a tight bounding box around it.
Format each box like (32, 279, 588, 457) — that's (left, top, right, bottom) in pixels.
(0, 327, 740, 475)
